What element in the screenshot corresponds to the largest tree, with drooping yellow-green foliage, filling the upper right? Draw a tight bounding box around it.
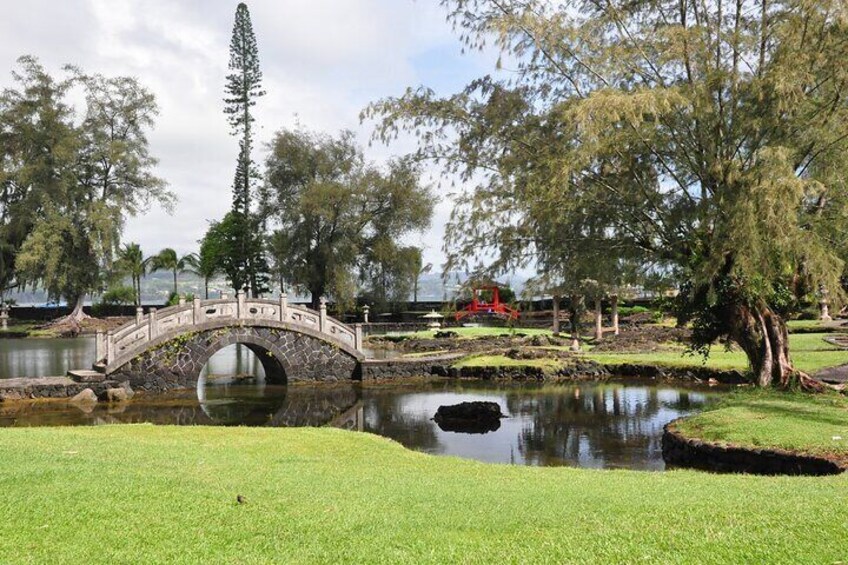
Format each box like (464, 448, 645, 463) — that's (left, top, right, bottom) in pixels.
(370, 0, 848, 387)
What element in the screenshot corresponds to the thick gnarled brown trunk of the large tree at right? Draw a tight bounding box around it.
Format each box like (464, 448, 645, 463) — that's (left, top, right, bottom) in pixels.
(730, 304, 825, 390)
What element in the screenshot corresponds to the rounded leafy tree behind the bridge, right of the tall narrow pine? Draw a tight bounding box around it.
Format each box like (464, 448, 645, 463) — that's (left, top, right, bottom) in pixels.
(262, 130, 433, 308)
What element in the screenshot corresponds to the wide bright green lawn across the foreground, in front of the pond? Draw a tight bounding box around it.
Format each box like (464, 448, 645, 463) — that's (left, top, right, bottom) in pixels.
(0, 425, 848, 563)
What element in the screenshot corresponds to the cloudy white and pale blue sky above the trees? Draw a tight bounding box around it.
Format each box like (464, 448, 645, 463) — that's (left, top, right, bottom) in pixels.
(0, 0, 495, 265)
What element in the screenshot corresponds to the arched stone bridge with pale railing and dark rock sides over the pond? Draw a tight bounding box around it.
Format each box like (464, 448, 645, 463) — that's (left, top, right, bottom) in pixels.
(94, 293, 365, 391)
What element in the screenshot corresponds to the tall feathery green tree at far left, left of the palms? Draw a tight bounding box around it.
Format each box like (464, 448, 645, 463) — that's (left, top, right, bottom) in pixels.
(6, 57, 173, 322)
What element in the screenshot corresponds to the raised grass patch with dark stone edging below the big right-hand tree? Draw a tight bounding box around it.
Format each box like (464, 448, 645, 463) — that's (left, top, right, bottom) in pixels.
(677, 389, 848, 462)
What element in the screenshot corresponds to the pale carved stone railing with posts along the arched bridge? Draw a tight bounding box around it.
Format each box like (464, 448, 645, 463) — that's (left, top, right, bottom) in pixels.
(95, 292, 362, 365)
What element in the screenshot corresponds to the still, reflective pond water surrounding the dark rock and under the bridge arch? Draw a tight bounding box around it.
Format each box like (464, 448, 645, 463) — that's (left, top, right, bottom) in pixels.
(0, 339, 721, 470)
